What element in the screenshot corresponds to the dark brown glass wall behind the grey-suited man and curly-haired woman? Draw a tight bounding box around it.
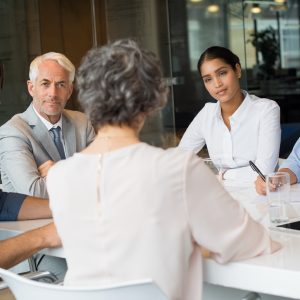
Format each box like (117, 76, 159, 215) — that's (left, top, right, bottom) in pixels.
(0, 0, 176, 147)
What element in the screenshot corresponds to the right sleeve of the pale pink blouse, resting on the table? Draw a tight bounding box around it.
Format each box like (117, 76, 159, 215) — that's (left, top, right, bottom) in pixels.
(185, 157, 272, 262)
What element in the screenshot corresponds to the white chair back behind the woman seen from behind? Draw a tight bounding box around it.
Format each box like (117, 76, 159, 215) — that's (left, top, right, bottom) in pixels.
(0, 268, 167, 300)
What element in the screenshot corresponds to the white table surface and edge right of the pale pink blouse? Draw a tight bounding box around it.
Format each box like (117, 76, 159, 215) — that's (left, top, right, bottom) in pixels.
(204, 184, 300, 299)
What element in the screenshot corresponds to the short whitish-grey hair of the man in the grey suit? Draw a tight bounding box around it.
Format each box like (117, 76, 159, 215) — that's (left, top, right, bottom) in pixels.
(29, 52, 75, 83)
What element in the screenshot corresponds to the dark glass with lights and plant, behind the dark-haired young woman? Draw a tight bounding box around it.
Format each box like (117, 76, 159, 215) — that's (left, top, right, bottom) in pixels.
(169, 0, 300, 156)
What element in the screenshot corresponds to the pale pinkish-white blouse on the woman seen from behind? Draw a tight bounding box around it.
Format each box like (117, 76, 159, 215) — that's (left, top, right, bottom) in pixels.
(47, 143, 271, 300)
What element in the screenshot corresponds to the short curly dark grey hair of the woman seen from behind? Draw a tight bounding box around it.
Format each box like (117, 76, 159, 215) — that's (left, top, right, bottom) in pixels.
(77, 39, 167, 129)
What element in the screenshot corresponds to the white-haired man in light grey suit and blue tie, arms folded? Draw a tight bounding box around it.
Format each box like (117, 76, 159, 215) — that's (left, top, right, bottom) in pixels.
(0, 52, 95, 198)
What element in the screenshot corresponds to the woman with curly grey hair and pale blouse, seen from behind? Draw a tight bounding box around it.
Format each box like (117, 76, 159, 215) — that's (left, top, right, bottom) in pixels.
(47, 40, 277, 300)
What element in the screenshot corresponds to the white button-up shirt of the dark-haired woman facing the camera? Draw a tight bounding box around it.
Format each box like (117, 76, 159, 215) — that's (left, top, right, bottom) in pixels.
(179, 91, 281, 181)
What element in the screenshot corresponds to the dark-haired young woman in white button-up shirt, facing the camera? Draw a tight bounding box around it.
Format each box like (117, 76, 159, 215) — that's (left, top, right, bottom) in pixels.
(179, 46, 280, 181)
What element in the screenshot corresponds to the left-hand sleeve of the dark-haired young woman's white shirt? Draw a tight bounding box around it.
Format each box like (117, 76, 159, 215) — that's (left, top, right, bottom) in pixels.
(178, 110, 205, 153)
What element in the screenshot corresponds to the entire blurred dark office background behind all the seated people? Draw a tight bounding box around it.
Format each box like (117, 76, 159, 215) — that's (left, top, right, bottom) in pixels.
(0, 0, 300, 157)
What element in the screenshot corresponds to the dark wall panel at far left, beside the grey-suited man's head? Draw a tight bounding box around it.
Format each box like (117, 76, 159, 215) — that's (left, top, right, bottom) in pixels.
(0, 0, 41, 125)
